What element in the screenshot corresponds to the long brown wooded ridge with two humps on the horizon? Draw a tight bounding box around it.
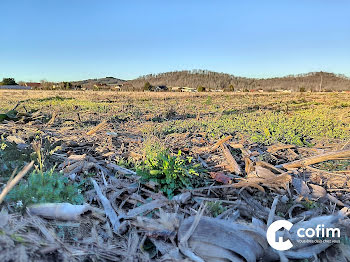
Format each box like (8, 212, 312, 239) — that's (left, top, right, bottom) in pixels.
(128, 70, 350, 91)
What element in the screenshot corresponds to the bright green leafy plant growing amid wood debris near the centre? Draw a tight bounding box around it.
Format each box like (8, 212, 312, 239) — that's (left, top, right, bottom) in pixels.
(137, 151, 200, 198)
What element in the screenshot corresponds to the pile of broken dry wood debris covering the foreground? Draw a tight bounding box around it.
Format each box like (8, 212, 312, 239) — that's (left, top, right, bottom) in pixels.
(0, 115, 350, 262)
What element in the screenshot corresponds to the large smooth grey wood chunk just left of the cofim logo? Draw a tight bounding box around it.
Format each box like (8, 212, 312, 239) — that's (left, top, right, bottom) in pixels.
(179, 217, 267, 262)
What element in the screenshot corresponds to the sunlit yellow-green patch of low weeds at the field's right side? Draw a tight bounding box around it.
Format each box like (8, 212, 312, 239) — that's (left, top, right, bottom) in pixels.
(147, 109, 350, 146)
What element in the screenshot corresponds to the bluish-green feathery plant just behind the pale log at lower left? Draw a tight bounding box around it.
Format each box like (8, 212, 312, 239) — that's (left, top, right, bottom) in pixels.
(6, 169, 84, 209)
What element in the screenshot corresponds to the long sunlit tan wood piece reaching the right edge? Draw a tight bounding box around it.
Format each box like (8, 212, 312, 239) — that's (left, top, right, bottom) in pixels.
(282, 150, 350, 169)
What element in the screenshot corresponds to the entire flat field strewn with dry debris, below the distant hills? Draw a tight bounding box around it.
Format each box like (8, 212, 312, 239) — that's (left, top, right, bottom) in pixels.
(0, 90, 350, 261)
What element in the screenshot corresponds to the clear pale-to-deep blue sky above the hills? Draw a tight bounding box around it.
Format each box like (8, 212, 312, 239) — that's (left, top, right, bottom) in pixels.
(0, 0, 350, 81)
